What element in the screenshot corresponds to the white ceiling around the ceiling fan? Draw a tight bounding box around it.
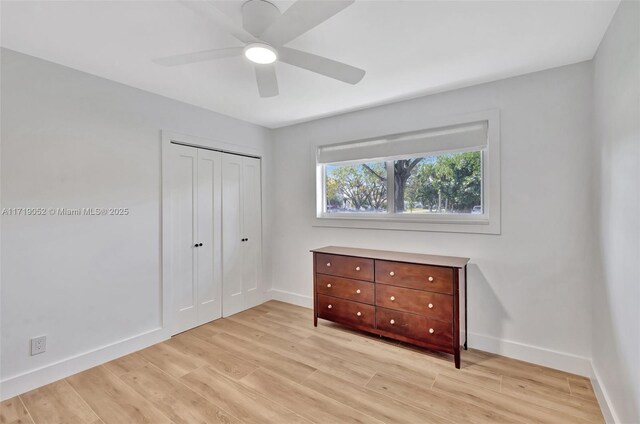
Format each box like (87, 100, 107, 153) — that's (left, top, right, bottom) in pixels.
(1, 0, 618, 128)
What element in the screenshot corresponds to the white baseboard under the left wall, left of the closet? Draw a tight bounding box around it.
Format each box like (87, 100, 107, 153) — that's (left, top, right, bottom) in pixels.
(0, 328, 168, 400)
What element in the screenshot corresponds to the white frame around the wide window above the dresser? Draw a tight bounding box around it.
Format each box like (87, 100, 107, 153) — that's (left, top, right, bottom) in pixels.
(314, 110, 500, 234)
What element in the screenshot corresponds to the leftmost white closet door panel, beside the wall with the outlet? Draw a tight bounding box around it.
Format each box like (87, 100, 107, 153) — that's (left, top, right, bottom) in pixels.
(170, 144, 198, 334)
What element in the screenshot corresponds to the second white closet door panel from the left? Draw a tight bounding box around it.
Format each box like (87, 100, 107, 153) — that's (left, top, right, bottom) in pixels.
(196, 149, 222, 325)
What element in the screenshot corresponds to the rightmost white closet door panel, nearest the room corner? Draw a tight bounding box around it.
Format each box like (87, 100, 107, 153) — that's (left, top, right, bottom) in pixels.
(242, 157, 262, 309)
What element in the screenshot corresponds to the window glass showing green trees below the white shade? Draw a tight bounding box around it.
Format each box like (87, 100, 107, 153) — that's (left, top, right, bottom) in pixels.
(324, 150, 482, 214)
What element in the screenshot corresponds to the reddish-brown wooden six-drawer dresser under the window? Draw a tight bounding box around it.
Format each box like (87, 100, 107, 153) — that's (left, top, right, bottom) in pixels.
(311, 246, 469, 368)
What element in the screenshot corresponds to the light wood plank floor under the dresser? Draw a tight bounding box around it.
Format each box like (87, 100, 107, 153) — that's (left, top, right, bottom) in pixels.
(0, 301, 603, 424)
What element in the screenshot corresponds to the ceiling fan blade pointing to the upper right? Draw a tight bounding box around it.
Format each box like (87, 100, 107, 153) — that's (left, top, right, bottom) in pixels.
(260, 0, 355, 46)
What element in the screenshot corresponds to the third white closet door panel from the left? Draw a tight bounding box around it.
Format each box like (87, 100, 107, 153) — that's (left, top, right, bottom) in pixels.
(222, 154, 245, 317)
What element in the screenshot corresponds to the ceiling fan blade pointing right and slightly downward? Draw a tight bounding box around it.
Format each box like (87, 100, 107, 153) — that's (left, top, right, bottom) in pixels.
(278, 47, 366, 84)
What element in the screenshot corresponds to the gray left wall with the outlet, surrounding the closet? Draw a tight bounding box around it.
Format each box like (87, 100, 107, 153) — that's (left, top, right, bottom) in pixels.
(1, 50, 272, 398)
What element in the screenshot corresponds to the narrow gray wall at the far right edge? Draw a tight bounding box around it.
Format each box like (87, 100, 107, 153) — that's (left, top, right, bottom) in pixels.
(591, 1, 640, 423)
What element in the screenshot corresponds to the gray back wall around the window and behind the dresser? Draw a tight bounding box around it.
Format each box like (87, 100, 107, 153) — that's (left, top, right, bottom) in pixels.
(271, 62, 593, 374)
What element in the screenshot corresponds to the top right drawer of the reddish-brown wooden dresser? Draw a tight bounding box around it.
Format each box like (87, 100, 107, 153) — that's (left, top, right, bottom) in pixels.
(375, 261, 453, 294)
